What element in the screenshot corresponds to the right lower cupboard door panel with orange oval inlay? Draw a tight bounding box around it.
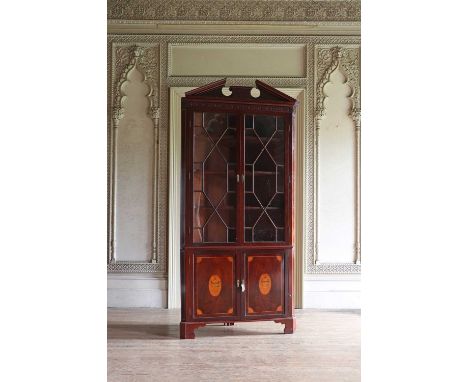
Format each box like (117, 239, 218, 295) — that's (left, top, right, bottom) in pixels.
(245, 252, 285, 317)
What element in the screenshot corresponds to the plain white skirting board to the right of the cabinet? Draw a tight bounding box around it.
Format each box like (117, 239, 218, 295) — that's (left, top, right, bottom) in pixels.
(303, 274, 361, 309)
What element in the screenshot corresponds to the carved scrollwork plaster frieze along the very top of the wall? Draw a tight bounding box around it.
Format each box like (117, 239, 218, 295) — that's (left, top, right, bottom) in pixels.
(107, 0, 361, 22)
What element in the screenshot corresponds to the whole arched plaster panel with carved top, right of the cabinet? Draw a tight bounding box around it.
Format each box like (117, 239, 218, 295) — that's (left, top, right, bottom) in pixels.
(313, 46, 361, 264)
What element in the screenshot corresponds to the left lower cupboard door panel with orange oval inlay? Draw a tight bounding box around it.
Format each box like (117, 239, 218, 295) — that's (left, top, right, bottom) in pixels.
(193, 254, 236, 319)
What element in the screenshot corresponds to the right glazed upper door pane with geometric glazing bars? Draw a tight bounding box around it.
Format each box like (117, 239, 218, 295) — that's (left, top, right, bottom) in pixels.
(244, 115, 285, 242)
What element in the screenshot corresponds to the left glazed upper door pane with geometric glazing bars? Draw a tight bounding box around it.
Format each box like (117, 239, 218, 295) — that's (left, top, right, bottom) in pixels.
(193, 112, 237, 243)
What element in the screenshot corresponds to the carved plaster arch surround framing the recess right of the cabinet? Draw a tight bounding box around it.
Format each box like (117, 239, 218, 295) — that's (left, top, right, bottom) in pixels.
(313, 46, 361, 264)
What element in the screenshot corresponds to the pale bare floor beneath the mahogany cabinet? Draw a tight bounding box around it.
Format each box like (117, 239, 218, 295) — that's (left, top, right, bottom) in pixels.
(107, 308, 361, 382)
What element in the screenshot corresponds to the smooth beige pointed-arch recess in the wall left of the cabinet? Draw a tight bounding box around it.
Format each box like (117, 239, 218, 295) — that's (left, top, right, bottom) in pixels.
(114, 66, 154, 261)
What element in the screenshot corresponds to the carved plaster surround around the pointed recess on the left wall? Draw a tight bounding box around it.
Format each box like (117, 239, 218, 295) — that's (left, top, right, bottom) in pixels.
(107, 42, 167, 274)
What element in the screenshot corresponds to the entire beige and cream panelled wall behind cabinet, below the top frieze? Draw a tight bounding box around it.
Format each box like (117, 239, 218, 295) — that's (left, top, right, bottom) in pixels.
(108, 3, 361, 308)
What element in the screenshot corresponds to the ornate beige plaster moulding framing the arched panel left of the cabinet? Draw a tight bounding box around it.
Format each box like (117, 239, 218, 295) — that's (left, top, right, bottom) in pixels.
(108, 43, 166, 272)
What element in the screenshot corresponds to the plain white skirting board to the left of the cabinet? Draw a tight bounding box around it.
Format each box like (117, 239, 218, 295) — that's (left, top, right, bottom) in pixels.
(107, 274, 167, 308)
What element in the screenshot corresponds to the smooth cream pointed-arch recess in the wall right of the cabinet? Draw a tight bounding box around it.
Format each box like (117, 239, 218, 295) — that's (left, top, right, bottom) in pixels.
(318, 67, 356, 263)
